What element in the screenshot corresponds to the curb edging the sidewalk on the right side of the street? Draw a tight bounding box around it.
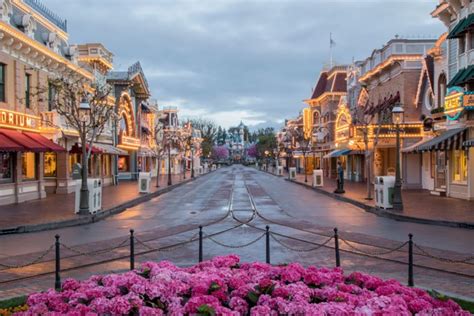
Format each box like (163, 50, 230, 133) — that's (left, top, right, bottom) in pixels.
(255, 169, 474, 229)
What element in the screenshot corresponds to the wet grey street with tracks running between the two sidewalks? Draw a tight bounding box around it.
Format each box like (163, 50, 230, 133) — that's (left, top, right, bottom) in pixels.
(0, 166, 474, 298)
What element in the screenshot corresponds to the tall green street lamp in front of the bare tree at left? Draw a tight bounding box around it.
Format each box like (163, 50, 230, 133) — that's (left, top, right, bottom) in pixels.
(78, 97, 91, 215)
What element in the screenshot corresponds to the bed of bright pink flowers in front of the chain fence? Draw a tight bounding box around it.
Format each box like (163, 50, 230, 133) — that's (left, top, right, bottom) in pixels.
(18, 255, 469, 315)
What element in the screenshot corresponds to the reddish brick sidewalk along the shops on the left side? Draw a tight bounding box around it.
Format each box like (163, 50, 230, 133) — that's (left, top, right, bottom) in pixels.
(0, 173, 206, 235)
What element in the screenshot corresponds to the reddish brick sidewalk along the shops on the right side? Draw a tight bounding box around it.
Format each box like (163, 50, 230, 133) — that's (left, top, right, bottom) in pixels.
(262, 169, 474, 229)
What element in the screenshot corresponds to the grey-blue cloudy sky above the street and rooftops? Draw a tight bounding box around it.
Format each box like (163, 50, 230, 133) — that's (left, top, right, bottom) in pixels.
(49, 0, 444, 127)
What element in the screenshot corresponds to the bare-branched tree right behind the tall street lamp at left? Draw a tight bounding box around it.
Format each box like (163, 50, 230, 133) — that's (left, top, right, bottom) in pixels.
(46, 77, 117, 214)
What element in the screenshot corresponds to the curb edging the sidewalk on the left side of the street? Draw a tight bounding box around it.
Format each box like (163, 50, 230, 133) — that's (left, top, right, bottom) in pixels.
(0, 171, 213, 235)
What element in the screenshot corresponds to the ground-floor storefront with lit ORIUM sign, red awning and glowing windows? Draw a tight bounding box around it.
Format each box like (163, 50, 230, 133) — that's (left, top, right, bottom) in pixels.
(0, 109, 65, 205)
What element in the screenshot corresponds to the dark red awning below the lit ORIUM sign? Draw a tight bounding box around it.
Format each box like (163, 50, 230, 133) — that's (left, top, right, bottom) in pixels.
(0, 128, 65, 152)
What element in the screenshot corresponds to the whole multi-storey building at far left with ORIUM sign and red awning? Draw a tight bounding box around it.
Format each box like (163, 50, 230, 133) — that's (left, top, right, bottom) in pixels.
(0, 0, 95, 205)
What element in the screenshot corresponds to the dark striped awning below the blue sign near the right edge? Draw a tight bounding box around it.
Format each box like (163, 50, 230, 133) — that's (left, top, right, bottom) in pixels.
(404, 127, 467, 152)
